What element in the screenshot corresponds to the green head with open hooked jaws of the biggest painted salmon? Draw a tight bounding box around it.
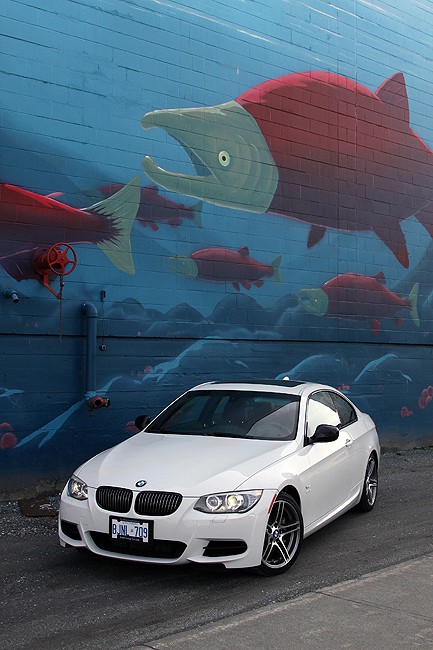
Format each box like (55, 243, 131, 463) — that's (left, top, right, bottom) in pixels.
(141, 101, 278, 212)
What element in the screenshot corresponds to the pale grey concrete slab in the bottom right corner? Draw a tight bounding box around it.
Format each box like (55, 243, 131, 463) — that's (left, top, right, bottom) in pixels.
(141, 554, 433, 650)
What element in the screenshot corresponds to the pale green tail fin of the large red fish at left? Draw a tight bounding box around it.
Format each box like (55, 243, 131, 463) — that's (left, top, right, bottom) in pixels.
(87, 176, 141, 275)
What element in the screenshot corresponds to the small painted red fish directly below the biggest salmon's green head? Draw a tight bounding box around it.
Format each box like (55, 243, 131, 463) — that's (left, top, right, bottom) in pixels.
(171, 246, 281, 291)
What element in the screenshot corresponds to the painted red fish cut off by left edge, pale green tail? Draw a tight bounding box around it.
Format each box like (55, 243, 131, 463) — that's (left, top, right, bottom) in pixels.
(0, 177, 140, 281)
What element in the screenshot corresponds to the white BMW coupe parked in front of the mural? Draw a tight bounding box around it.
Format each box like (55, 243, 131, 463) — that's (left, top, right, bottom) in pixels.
(59, 380, 380, 575)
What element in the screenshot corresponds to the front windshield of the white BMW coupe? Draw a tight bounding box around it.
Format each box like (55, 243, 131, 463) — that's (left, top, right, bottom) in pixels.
(146, 390, 299, 440)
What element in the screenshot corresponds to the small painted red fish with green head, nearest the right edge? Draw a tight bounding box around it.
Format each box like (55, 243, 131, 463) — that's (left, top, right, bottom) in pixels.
(299, 272, 419, 336)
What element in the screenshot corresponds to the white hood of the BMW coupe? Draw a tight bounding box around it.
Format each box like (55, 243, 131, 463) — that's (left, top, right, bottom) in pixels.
(76, 433, 297, 496)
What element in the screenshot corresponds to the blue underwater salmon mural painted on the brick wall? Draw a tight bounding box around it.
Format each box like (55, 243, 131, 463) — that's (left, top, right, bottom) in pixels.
(0, 0, 433, 491)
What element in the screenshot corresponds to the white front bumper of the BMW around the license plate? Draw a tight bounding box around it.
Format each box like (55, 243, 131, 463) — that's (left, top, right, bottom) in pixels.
(59, 480, 275, 568)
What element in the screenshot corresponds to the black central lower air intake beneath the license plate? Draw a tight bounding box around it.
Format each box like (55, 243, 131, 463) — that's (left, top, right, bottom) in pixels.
(90, 531, 186, 560)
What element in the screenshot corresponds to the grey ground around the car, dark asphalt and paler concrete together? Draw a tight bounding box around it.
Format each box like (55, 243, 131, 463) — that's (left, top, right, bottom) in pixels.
(0, 448, 433, 650)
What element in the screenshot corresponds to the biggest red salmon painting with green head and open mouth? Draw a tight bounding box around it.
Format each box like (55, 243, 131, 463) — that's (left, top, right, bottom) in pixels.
(142, 71, 433, 268)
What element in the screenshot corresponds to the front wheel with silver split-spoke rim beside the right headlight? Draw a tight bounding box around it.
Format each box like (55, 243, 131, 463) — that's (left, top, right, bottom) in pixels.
(256, 492, 304, 576)
